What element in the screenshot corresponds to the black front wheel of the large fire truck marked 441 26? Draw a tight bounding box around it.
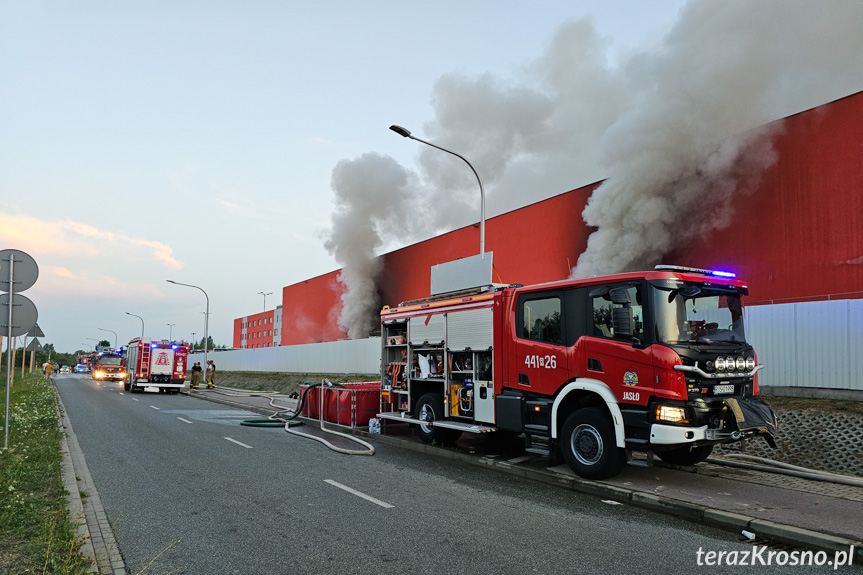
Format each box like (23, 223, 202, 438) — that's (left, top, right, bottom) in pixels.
(560, 407, 626, 479)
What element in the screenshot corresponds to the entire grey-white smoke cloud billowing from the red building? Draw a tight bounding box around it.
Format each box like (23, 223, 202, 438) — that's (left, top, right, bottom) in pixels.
(327, 0, 863, 337)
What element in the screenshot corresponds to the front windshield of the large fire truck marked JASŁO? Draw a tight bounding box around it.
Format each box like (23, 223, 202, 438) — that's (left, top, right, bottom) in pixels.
(653, 284, 746, 345)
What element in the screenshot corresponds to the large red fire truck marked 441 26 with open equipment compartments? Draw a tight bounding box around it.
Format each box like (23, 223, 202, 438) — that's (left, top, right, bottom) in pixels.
(378, 266, 776, 479)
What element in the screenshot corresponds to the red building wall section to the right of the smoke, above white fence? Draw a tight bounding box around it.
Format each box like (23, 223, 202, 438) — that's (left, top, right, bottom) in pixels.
(668, 92, 863, 305)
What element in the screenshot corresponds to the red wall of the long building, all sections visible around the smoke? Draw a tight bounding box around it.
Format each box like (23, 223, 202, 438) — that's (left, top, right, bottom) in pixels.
(235, 88, 863, 345)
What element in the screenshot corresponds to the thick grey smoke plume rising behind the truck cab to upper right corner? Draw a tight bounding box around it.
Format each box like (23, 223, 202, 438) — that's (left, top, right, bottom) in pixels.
(573, 1, 863, 277)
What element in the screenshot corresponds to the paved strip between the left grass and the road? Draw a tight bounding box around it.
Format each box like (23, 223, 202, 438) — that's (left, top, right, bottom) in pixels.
(55, 384, 128, 575)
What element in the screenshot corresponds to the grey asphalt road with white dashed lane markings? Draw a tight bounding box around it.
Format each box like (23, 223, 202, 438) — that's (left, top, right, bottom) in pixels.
(55, 374, 832, 575)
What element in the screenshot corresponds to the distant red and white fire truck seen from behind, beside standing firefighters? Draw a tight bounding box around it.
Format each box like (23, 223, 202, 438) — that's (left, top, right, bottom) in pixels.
(124, 338, 189, 393)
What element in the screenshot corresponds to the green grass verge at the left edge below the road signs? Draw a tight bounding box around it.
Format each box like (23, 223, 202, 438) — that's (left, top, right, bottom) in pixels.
(0, 374, 89, 575)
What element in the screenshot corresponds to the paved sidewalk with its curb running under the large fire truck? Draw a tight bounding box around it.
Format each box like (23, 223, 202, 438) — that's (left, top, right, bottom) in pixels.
(189, 388, 863, 565)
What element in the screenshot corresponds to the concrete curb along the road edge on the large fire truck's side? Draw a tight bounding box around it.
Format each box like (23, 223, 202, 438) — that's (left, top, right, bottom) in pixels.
(188, 390, 863, 564)
